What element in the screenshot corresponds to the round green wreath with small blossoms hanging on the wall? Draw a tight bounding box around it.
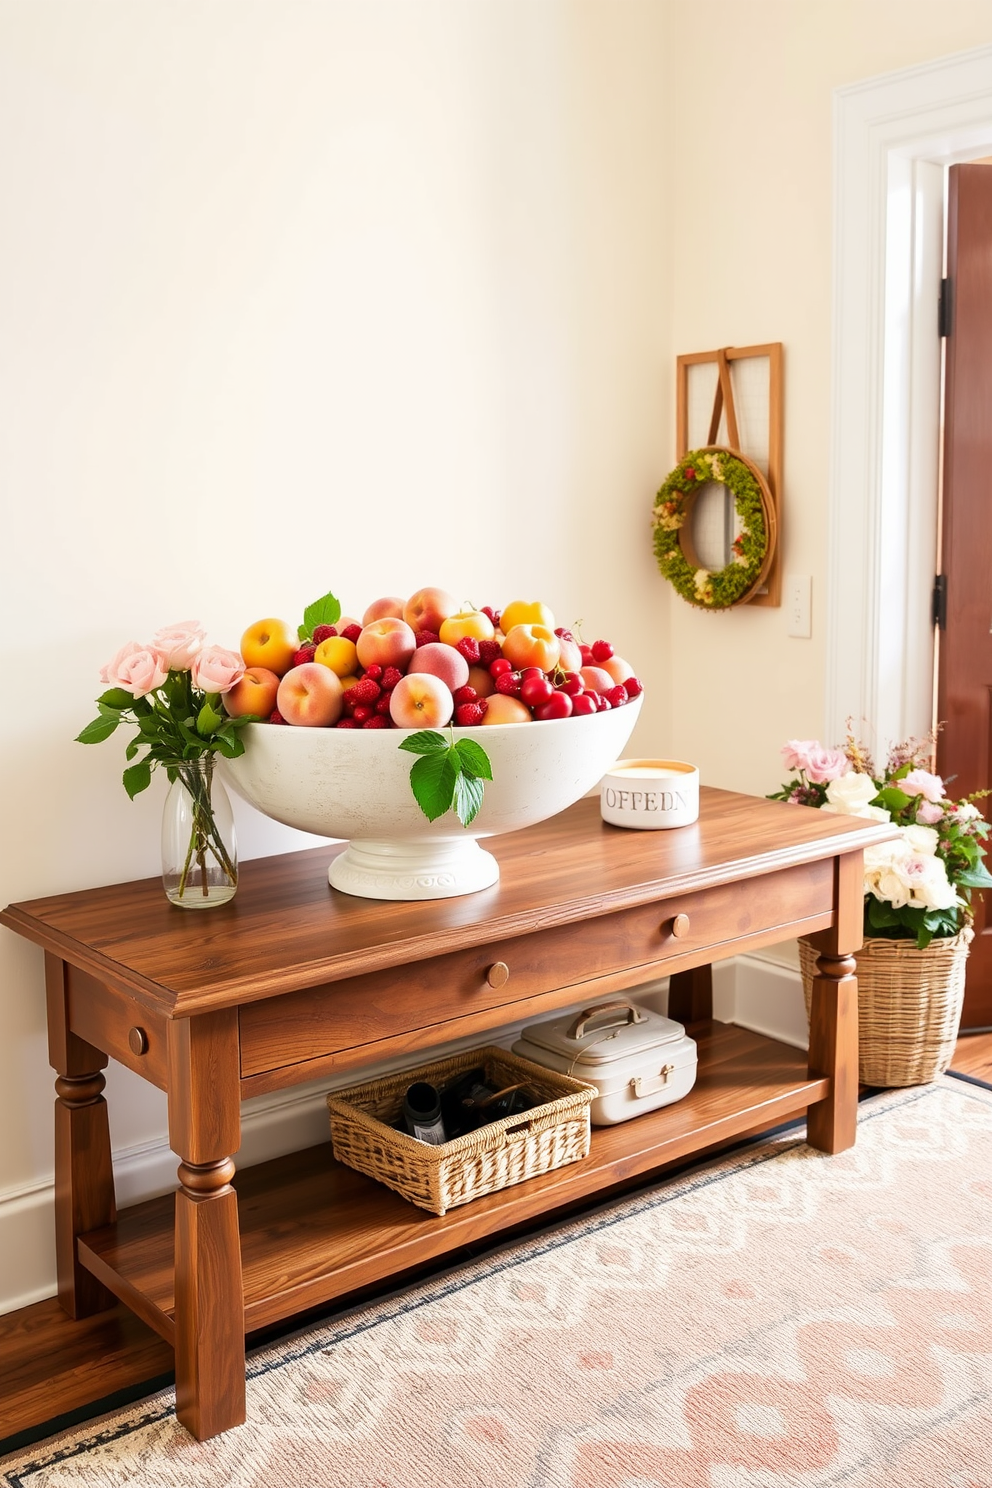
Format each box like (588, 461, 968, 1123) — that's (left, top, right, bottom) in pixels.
(651, 448, 772, 610)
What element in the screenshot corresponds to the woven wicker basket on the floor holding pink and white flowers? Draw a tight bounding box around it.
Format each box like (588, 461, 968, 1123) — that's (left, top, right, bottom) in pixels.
(799, 926, 973, 1086)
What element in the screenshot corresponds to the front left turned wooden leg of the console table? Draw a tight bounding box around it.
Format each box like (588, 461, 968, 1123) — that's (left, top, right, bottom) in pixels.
(168, 1010, 245, 1442)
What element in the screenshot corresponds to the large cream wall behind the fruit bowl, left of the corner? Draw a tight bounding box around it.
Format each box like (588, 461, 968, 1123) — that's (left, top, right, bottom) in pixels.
(0, 0, 671, 1309)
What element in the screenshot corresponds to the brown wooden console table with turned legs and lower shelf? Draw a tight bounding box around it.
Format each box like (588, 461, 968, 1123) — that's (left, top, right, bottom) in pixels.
(0, 790, 892, 1439)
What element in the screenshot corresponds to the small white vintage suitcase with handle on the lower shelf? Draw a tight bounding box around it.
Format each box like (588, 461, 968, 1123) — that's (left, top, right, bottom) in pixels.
(513, 1001, 696, 1126)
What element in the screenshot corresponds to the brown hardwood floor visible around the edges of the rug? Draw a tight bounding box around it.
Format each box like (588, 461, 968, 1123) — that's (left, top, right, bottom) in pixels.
(0, 1034, 992, 1452)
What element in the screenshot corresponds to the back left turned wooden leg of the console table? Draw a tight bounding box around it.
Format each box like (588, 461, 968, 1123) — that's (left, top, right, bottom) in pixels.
(45, 952, 117, 1318)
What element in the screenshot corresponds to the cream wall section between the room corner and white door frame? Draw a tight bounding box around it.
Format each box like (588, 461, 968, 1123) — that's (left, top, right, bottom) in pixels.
(669, 0, 992, 793)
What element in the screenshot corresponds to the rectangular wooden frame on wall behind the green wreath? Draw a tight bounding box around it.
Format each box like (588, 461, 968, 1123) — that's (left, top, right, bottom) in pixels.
(675, 341, 782, 606)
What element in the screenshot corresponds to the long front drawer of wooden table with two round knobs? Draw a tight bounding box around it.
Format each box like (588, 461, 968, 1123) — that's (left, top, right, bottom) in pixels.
(239, 860, 833, 1079)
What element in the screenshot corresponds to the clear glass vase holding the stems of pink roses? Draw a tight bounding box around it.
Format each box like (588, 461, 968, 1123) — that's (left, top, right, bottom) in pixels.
(162, 754, 238, 909)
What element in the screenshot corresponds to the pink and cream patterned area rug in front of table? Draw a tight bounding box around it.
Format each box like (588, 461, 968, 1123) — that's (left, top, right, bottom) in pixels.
(0, 1079, 992, 1488)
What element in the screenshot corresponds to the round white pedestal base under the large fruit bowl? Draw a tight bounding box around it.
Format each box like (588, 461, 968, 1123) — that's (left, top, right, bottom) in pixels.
(327, 838, 500, 899)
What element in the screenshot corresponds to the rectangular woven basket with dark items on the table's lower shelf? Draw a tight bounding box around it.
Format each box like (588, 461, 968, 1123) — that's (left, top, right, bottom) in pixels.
(327, 1048, 596, 1214)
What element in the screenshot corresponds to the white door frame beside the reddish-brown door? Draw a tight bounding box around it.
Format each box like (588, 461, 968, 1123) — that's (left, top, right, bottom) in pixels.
(824, 46, 992, 747)
